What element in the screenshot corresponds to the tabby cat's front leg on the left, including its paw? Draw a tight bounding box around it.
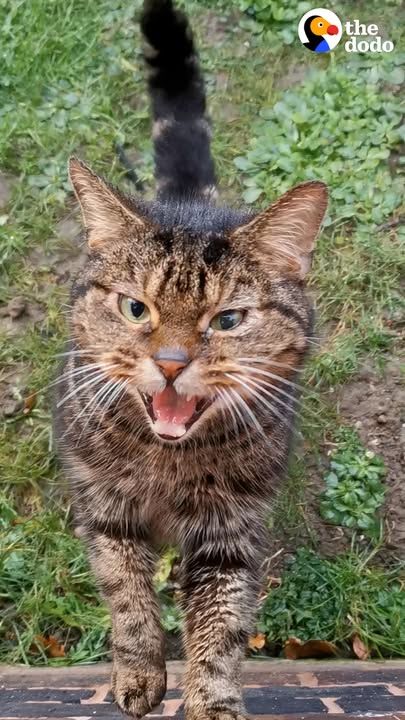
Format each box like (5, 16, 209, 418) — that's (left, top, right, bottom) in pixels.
(89, 534, 166, 718)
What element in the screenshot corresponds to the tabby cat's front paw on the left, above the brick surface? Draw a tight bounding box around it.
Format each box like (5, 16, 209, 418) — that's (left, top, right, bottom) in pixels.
(111, 665, 166, 718)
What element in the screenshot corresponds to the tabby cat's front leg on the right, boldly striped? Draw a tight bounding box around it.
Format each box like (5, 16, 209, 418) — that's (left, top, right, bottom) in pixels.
(183, 546, 259, 720)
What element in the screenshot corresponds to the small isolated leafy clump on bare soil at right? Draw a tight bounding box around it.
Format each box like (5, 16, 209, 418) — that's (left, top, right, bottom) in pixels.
(320, 430, 386, 538)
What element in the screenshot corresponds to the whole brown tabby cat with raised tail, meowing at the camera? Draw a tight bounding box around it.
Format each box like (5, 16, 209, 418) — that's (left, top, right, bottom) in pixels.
(55, 0, 327, 720)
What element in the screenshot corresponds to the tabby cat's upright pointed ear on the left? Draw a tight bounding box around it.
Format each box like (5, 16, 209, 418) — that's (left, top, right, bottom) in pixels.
(69, 157, 145, 248)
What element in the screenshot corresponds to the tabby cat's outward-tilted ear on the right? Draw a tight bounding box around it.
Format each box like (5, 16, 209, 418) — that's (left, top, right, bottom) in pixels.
(232, 181, 328, 280)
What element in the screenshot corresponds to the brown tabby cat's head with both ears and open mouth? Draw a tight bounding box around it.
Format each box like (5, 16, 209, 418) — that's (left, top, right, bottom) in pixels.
(70, 159, 327, 442)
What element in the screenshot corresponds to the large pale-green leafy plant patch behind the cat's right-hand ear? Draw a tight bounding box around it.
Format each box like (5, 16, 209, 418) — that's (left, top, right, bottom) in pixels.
(235, 53, 403, 224)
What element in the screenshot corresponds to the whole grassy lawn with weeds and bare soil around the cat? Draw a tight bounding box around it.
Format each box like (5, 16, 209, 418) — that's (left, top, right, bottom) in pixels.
(0, 0, 405, 664)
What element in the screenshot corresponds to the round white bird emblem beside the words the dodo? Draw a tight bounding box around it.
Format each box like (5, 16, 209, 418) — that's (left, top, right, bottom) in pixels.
(298, 8, 343, 53)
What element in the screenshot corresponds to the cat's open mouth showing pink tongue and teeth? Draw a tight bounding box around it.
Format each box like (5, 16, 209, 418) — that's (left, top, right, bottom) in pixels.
(141, 385, 212, 440)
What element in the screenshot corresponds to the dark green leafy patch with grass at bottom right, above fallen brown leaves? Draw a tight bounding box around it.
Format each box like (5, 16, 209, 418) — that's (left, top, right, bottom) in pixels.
(259, 548, 405, 655)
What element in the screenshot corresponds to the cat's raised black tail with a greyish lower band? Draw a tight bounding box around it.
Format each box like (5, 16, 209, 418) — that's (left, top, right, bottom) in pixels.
(141, 0, 216, 202)
